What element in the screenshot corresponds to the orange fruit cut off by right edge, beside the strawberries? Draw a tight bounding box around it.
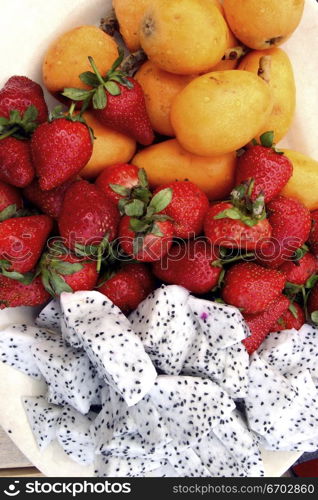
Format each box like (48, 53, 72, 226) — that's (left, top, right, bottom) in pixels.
(282, 149, 318, 210)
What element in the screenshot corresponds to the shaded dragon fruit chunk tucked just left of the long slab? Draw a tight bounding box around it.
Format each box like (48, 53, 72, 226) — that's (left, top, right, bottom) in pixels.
(31, 338, 101, 414)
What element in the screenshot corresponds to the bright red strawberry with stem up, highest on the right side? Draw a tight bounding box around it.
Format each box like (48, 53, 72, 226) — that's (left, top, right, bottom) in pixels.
(236, 132, 293, 203)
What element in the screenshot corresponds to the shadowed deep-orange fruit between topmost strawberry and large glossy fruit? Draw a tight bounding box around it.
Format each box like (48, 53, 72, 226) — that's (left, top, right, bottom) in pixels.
(135, 61, 193, 136)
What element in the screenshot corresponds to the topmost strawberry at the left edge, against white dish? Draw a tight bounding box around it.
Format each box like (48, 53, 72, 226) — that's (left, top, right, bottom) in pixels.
(0, 76, 48, 123)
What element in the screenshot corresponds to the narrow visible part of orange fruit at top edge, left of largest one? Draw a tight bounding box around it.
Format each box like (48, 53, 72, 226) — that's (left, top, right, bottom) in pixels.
(113, 0, 152, 52)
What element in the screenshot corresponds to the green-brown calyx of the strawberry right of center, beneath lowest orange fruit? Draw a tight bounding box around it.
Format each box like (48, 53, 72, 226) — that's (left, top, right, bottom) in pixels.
(214, 179, 266, 227)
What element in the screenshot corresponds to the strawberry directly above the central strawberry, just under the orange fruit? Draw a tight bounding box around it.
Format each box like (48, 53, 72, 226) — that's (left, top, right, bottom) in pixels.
(95, 163, 151, 207)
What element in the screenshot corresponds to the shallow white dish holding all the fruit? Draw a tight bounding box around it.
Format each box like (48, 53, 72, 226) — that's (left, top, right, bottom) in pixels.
(0, 0, 318, 477)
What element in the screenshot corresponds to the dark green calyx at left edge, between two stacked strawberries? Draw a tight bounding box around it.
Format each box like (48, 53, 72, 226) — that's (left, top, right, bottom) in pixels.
(0, 105, 38, 140)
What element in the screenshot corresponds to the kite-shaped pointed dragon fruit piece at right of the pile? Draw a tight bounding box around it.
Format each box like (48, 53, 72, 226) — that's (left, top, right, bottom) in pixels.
(245, 353, 298, 436)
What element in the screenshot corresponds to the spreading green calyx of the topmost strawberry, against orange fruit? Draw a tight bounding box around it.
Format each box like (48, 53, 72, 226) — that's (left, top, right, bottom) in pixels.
(62, 49, 133, 110)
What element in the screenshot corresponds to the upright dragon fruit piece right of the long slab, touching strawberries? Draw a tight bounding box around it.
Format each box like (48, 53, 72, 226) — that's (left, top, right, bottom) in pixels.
(129, 285, 198, 375)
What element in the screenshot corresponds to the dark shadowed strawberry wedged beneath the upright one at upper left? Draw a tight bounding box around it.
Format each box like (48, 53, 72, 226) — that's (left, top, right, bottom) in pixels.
(23, 179, 74, 219)
